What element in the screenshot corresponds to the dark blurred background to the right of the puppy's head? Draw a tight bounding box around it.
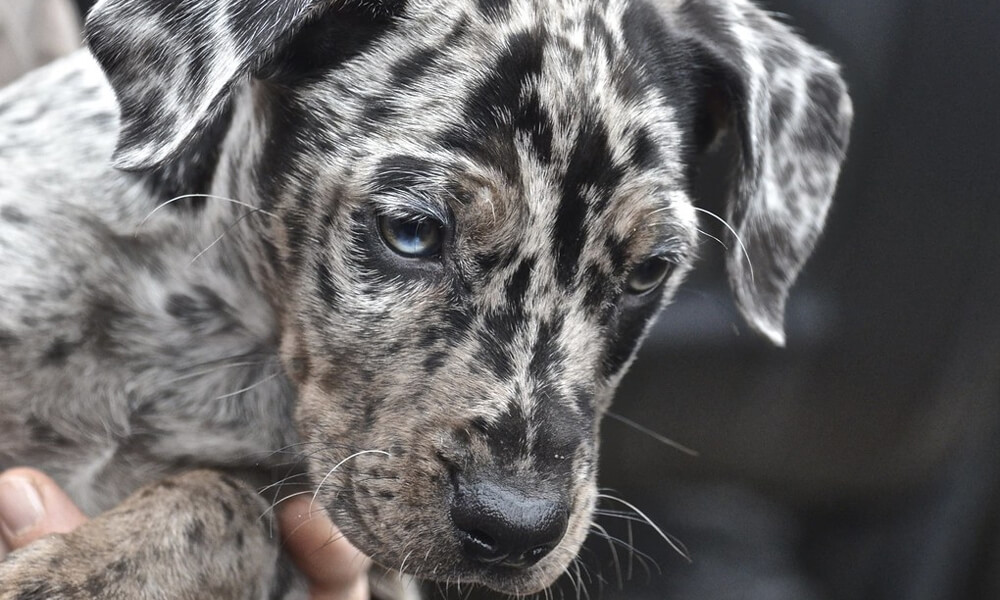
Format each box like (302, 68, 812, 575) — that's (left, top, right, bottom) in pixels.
(11, 0, 1000, 600)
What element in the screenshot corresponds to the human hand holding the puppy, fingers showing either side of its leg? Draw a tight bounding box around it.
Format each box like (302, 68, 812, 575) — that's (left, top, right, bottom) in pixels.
(0, 468, 370, 600)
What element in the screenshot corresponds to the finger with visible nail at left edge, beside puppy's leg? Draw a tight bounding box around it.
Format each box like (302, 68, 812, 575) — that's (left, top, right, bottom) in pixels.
(0, 468, 87, 550)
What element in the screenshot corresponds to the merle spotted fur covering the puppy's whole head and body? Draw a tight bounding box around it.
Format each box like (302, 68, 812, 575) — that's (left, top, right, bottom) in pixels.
(0, 0, 851, 600)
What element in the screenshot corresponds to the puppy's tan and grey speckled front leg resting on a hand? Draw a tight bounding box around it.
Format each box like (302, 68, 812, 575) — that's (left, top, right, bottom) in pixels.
(0, 471, 281, 600)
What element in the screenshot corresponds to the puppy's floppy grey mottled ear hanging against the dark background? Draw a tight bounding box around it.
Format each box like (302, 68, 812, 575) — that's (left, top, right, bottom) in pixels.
(675, 0, 853, 345)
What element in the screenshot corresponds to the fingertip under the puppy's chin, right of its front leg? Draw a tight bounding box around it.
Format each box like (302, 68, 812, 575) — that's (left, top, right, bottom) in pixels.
(278, 498, 371, 600)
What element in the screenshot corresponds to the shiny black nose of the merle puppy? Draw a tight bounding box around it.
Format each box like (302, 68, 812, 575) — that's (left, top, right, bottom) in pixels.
(451, 477, 569, 567)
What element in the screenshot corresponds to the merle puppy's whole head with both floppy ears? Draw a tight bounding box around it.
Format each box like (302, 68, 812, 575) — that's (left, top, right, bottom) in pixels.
(88, 0, 851, 593)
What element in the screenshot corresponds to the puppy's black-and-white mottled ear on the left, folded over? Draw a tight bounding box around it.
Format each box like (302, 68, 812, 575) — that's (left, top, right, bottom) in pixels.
(86, 0, 390, 170)
